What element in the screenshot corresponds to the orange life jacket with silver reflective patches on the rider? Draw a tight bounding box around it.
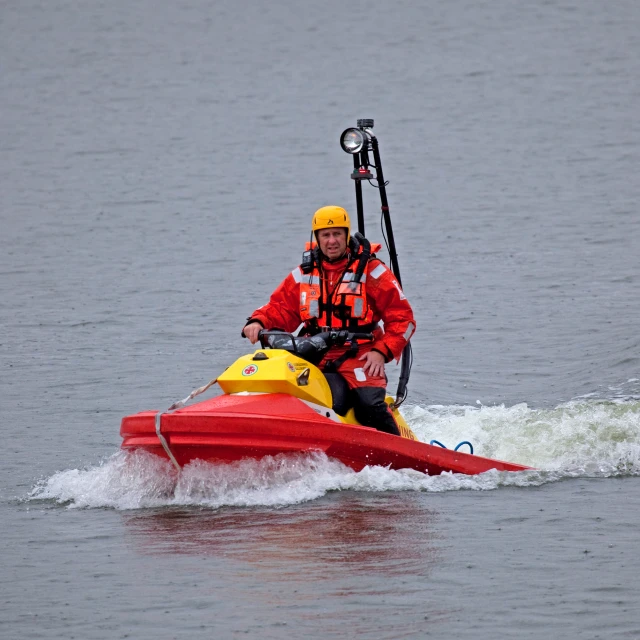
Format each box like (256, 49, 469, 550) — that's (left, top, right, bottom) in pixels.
(299, 238, 381, 333)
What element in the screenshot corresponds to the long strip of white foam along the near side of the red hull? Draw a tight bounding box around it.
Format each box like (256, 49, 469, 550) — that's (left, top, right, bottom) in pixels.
(29, 451, 546, 509)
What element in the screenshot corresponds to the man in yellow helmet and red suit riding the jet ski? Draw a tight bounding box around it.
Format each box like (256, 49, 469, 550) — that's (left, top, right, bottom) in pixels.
(242, 206, 415, 435)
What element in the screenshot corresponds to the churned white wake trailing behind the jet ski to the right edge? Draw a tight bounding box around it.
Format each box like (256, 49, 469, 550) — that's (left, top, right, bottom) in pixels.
(404, 400, 640, 475)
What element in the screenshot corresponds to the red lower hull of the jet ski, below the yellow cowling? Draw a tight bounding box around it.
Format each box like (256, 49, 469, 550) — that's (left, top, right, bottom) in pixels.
(120, 394, 529, 475)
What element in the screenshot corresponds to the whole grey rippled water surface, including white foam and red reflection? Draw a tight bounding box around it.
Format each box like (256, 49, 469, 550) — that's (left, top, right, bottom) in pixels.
(0, 0, 640, 639)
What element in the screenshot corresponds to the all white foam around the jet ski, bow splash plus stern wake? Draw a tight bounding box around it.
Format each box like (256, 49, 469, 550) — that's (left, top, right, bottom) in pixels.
(28, 399, 640, 509)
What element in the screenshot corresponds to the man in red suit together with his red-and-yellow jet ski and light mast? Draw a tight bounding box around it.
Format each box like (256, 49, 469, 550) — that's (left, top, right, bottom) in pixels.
(120, 124, 527, 475)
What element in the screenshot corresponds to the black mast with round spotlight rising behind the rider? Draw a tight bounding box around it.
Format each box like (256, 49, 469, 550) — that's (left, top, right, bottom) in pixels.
(340, 118, 413, 407)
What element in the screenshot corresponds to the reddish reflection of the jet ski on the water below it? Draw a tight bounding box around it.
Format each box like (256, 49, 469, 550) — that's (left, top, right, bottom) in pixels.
(123, 492, 438, 579)
